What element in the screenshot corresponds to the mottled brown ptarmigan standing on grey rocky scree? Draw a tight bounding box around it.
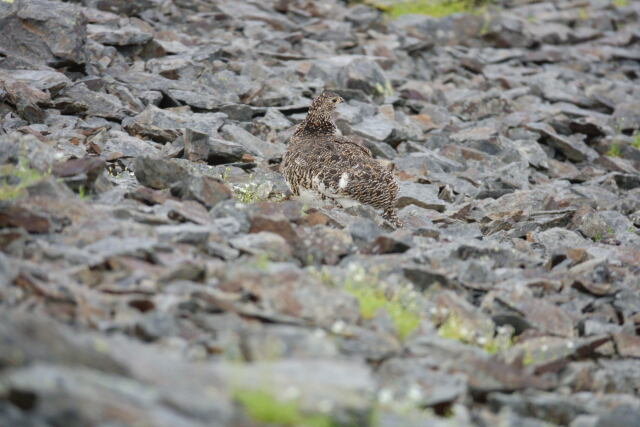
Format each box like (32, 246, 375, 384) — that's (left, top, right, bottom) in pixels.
(281, 92, 402, 227)
